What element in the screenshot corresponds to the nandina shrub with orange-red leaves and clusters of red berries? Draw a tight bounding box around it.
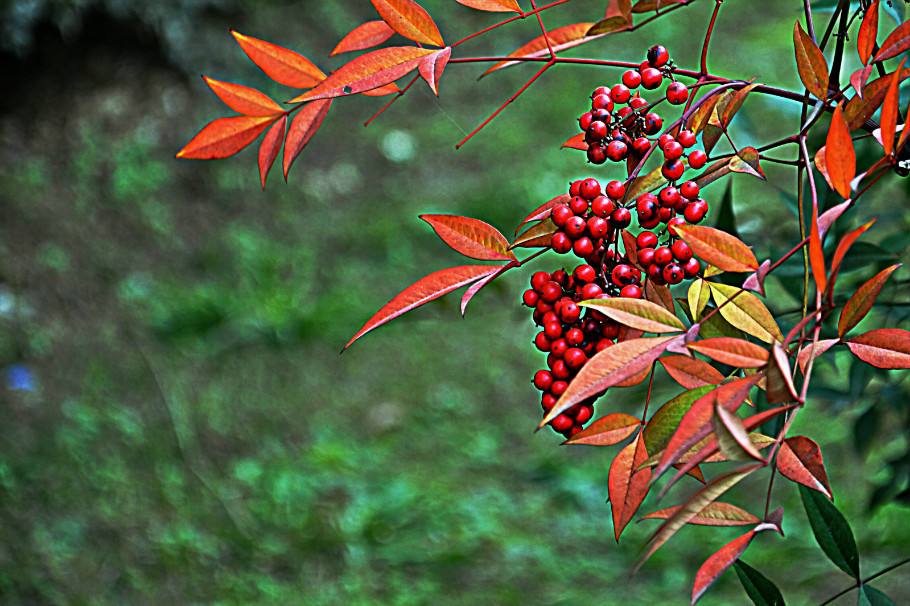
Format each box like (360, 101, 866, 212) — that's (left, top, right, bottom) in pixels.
(177, 0, 910, 604)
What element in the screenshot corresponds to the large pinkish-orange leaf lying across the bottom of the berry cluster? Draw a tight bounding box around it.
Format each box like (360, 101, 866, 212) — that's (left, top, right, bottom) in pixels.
(540, 336, 681, 427)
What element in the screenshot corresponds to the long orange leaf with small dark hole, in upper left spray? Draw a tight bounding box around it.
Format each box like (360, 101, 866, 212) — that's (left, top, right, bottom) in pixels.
(291, 46, 436, 103)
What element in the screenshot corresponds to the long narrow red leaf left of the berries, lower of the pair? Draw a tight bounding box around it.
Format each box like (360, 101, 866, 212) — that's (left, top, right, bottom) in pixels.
(344, 265, 502, 349)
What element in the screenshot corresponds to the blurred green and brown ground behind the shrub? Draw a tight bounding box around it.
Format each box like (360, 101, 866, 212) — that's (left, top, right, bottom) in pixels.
(0, 0, 910, 605)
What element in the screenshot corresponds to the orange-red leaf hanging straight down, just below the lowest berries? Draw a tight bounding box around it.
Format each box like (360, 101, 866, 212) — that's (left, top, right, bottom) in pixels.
(607, 433, 651, 542)
